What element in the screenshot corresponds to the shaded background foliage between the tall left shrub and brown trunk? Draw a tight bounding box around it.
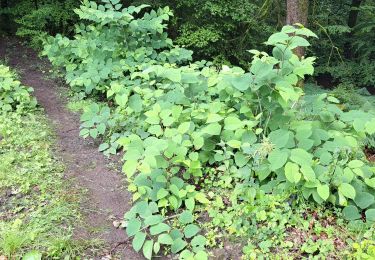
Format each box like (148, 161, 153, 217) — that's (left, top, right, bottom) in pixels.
(131, 0, 285, 66)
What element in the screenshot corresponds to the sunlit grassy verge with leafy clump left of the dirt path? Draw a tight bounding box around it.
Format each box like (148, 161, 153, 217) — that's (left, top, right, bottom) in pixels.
(0, 65, 84, 259)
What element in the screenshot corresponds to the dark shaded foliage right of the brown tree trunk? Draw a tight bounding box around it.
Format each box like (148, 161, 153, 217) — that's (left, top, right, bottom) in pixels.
(309, 0, 375, 88)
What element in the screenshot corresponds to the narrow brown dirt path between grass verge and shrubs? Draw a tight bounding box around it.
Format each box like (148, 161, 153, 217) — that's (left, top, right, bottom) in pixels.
(0, 39, 142, 260)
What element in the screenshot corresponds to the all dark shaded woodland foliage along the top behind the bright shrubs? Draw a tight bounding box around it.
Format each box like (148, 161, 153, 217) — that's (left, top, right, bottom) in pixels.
(0, 0, 375, 89)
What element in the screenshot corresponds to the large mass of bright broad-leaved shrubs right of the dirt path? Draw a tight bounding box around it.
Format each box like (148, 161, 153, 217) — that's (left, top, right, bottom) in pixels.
(44, 0, 375, 259)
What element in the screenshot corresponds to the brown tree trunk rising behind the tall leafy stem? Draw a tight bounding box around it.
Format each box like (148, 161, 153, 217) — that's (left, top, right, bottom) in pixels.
(286, 0, 309, 58)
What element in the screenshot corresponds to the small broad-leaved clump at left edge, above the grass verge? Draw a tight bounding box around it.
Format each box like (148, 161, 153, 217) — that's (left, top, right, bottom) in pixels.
(0, 64, 36, 112)
